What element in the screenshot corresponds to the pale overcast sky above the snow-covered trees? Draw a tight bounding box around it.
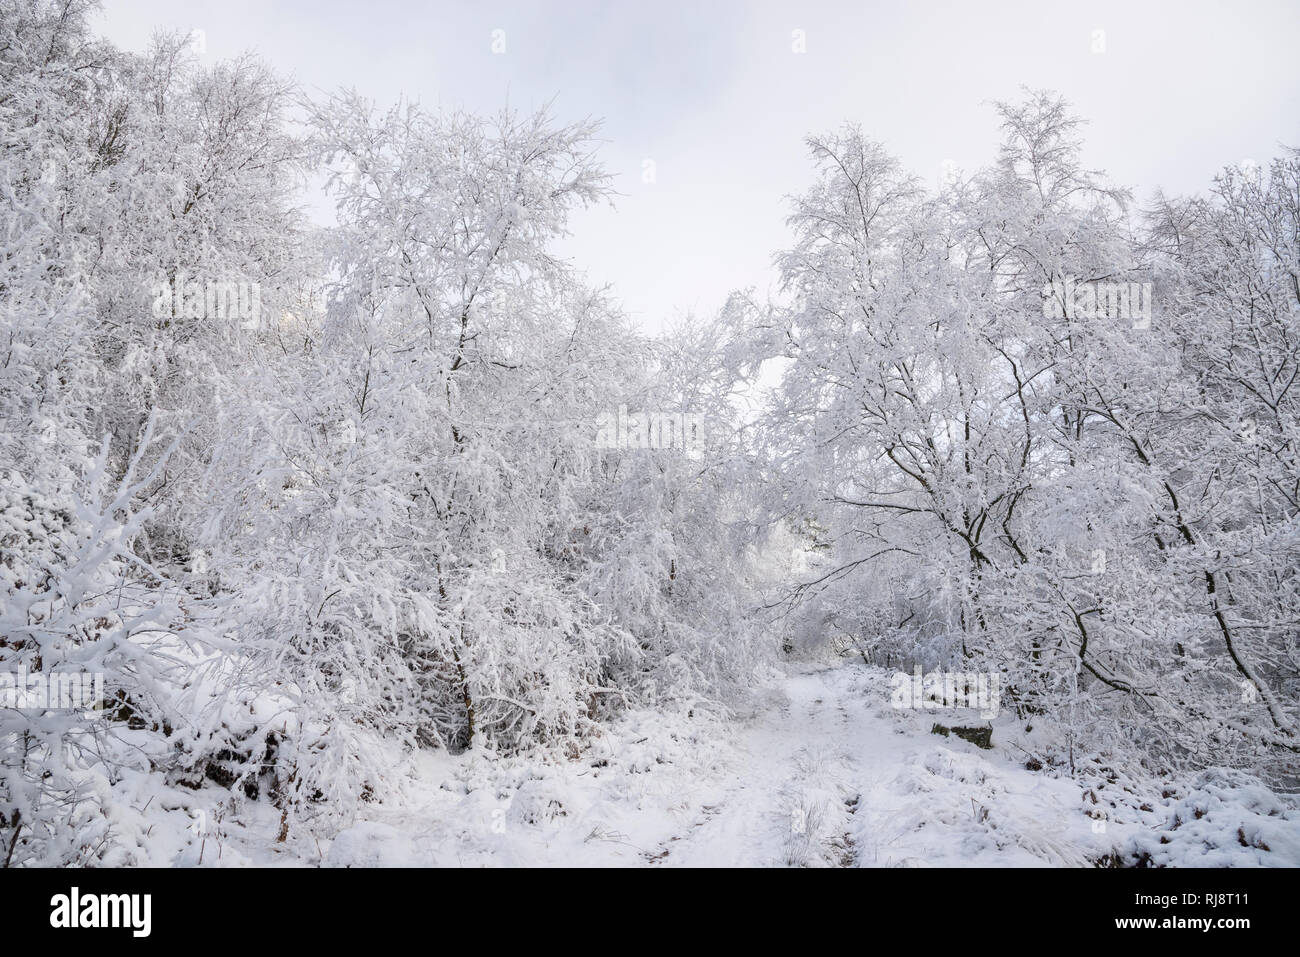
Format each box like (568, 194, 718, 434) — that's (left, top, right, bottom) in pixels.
(99, 0, 1300, 330)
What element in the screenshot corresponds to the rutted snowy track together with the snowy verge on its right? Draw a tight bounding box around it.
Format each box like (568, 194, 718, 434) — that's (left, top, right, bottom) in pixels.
(634, 666, 1092, 866)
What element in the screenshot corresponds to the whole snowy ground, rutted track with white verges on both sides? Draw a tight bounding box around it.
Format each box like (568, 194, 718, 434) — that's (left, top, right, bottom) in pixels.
(324, 664, 1300, 866)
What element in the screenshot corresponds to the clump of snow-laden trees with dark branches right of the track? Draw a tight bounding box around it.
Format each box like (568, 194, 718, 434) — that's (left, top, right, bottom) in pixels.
(738, 92, 1296, 780)
